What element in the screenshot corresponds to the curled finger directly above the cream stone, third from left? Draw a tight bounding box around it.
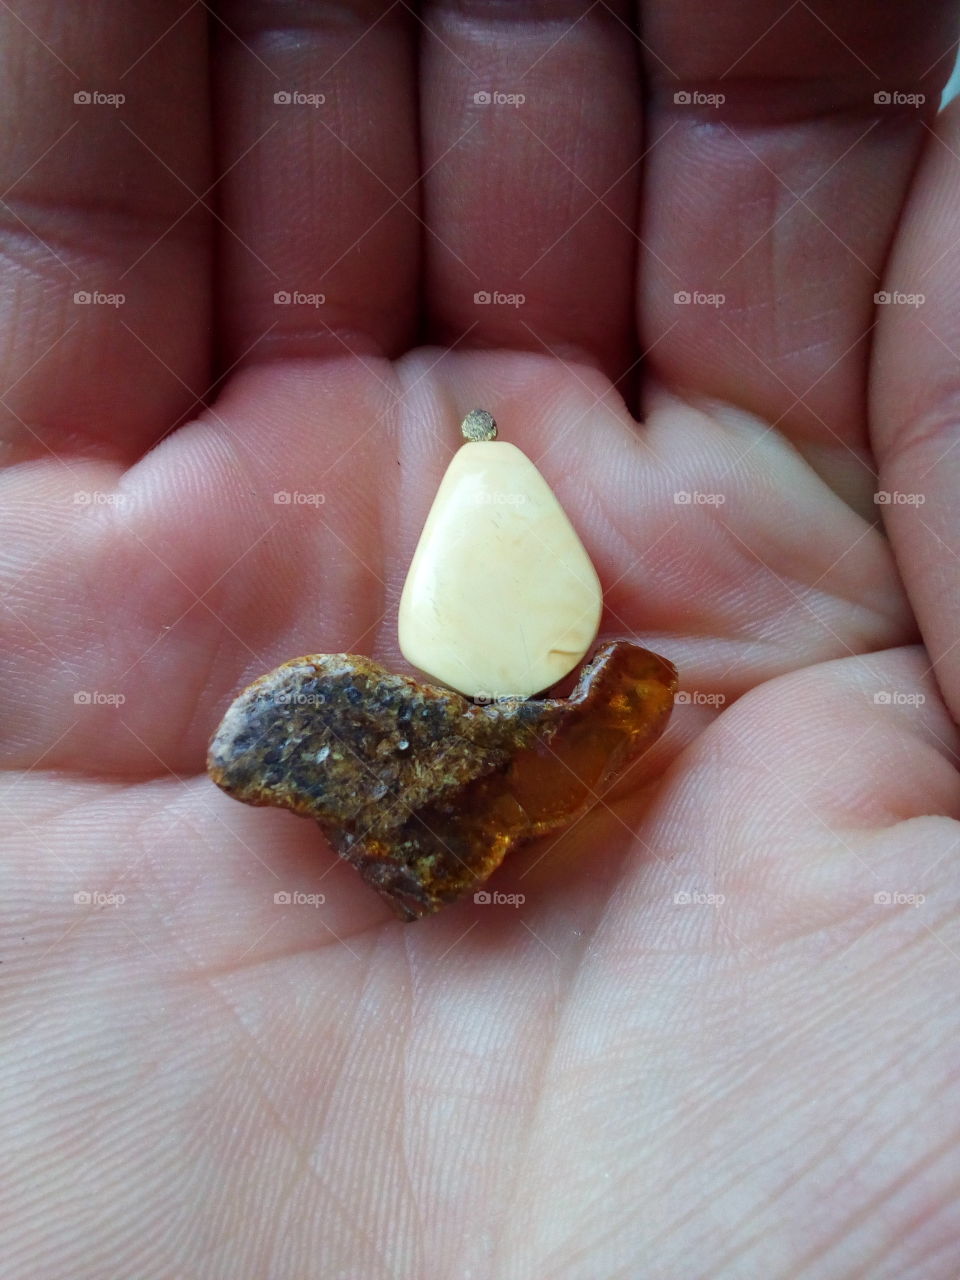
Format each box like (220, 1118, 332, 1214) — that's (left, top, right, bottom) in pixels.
(421, 0, 640, 380)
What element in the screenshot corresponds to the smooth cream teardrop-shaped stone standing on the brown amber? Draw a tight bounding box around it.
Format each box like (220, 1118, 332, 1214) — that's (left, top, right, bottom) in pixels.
(398, 440, 603, 698)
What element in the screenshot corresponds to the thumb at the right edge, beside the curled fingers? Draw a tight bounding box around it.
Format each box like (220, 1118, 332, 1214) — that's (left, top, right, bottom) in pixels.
(872, 102, 960, 719)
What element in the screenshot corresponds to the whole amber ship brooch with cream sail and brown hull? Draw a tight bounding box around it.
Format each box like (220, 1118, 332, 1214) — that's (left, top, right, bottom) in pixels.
(207, 410, 677, 920)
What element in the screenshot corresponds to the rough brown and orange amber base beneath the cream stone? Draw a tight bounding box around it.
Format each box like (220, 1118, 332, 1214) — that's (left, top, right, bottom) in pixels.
(207, 640, 677, 920)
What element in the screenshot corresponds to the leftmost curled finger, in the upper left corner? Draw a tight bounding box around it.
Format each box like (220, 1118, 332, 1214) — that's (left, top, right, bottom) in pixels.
(0, 0, 209, 461)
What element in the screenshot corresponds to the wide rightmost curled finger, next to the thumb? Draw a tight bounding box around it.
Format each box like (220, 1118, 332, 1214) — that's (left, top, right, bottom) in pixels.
(640, 0, 956, 506)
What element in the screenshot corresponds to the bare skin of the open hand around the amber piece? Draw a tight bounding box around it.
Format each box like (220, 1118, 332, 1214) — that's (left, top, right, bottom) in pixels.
(0, 0, 960, 1280)
